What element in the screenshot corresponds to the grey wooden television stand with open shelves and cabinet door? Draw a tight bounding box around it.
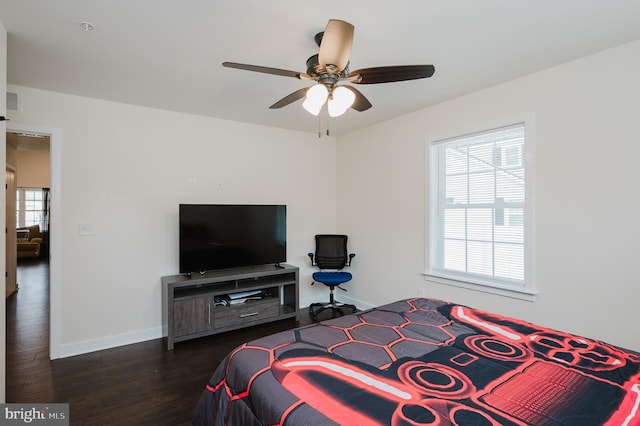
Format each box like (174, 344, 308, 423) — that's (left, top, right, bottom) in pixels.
(161, 264, 299, 350)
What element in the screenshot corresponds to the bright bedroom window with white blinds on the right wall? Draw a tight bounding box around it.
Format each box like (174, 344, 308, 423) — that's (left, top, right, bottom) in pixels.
(427, 124, 535, 298)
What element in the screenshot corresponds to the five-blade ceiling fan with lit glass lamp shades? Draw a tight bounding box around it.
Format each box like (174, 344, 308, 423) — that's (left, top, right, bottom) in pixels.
(222, 19, 435, 117)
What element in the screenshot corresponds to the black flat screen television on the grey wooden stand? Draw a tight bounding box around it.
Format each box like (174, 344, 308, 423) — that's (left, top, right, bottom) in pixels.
(179, 204, 287, 274)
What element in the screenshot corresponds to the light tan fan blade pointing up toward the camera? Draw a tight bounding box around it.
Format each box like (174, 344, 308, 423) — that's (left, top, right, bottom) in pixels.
(318, 19, 354, 74)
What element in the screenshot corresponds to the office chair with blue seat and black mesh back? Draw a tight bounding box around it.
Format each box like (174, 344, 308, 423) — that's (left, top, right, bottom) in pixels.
(308, 234, 358, 322)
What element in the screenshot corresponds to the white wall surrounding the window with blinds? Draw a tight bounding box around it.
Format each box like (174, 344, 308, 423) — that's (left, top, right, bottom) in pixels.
(337, 41, 640, 350)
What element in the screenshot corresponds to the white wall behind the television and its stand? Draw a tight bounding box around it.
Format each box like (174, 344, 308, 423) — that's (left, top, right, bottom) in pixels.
(10, 86, 336, 357)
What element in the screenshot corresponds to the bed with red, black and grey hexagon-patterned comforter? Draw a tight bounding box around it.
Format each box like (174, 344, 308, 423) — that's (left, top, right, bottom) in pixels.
(193, 298, 640, 426)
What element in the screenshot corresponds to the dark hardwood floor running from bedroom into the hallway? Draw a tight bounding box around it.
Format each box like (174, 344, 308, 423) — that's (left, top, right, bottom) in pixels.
(6, 261, 311, 425)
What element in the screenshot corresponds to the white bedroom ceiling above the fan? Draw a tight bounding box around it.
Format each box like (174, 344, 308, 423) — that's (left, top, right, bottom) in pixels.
(0, 0, 640, 135)
